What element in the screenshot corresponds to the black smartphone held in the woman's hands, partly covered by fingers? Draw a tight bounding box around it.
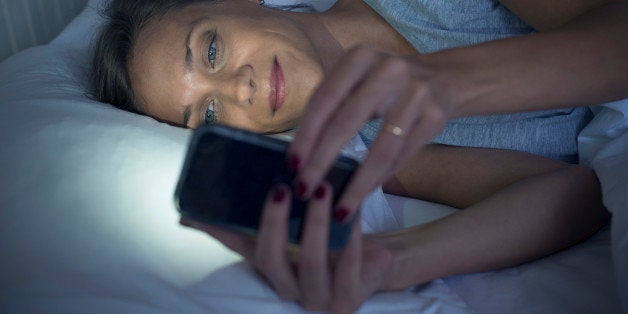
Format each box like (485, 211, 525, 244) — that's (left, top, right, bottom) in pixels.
(175, 125, 358, 250)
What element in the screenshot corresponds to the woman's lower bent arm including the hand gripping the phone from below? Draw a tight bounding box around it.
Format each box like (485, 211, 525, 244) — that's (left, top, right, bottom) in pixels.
(182, 147, 608, 313)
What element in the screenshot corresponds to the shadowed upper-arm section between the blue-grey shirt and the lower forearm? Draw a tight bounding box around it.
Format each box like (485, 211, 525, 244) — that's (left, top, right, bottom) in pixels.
(383, 144, 578, 208)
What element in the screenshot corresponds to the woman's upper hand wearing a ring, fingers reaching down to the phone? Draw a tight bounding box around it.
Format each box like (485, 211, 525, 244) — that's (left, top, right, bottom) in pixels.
(289, 47, 451, 221)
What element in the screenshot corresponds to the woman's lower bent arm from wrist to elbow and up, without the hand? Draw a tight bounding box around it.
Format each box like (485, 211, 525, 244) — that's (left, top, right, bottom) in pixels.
(374, 146, 609, 289)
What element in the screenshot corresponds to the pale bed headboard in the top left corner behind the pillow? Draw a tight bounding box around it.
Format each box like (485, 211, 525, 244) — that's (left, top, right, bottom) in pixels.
(0, 0, 87, 62)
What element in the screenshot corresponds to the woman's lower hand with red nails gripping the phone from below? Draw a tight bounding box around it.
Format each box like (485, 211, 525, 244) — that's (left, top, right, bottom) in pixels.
(181, 183, 392, 313)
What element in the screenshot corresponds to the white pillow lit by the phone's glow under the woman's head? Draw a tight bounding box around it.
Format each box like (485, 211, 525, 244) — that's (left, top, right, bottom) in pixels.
(0, 1, 468, 314)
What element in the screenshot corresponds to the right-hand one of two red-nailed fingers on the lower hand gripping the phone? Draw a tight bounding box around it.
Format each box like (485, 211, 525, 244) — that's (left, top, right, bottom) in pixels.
(298, 183, 332, 311)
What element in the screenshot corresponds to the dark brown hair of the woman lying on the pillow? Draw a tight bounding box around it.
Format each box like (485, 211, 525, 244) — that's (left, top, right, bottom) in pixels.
(91, 0, 313, 113)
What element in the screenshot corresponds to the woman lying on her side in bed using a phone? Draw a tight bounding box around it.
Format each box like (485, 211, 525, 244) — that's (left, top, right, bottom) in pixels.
(94, 0, 628, 312)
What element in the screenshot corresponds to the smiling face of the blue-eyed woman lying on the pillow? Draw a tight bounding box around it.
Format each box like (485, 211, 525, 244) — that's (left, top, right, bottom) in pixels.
(129, 0, 323, 132)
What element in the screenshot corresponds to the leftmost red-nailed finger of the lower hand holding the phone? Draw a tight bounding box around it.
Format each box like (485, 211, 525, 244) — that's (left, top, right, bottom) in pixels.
(252, 185, 300, 300)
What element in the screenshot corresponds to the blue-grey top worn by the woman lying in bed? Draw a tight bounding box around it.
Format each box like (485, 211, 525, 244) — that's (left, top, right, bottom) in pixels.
(360, 0, 593, 163)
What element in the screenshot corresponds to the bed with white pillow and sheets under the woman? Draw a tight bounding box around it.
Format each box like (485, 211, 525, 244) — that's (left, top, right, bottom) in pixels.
(0, 0, 628, 313)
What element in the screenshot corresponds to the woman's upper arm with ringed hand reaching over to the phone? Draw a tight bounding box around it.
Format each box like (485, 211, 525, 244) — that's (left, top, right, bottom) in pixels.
(290, 0, 628, 219)
